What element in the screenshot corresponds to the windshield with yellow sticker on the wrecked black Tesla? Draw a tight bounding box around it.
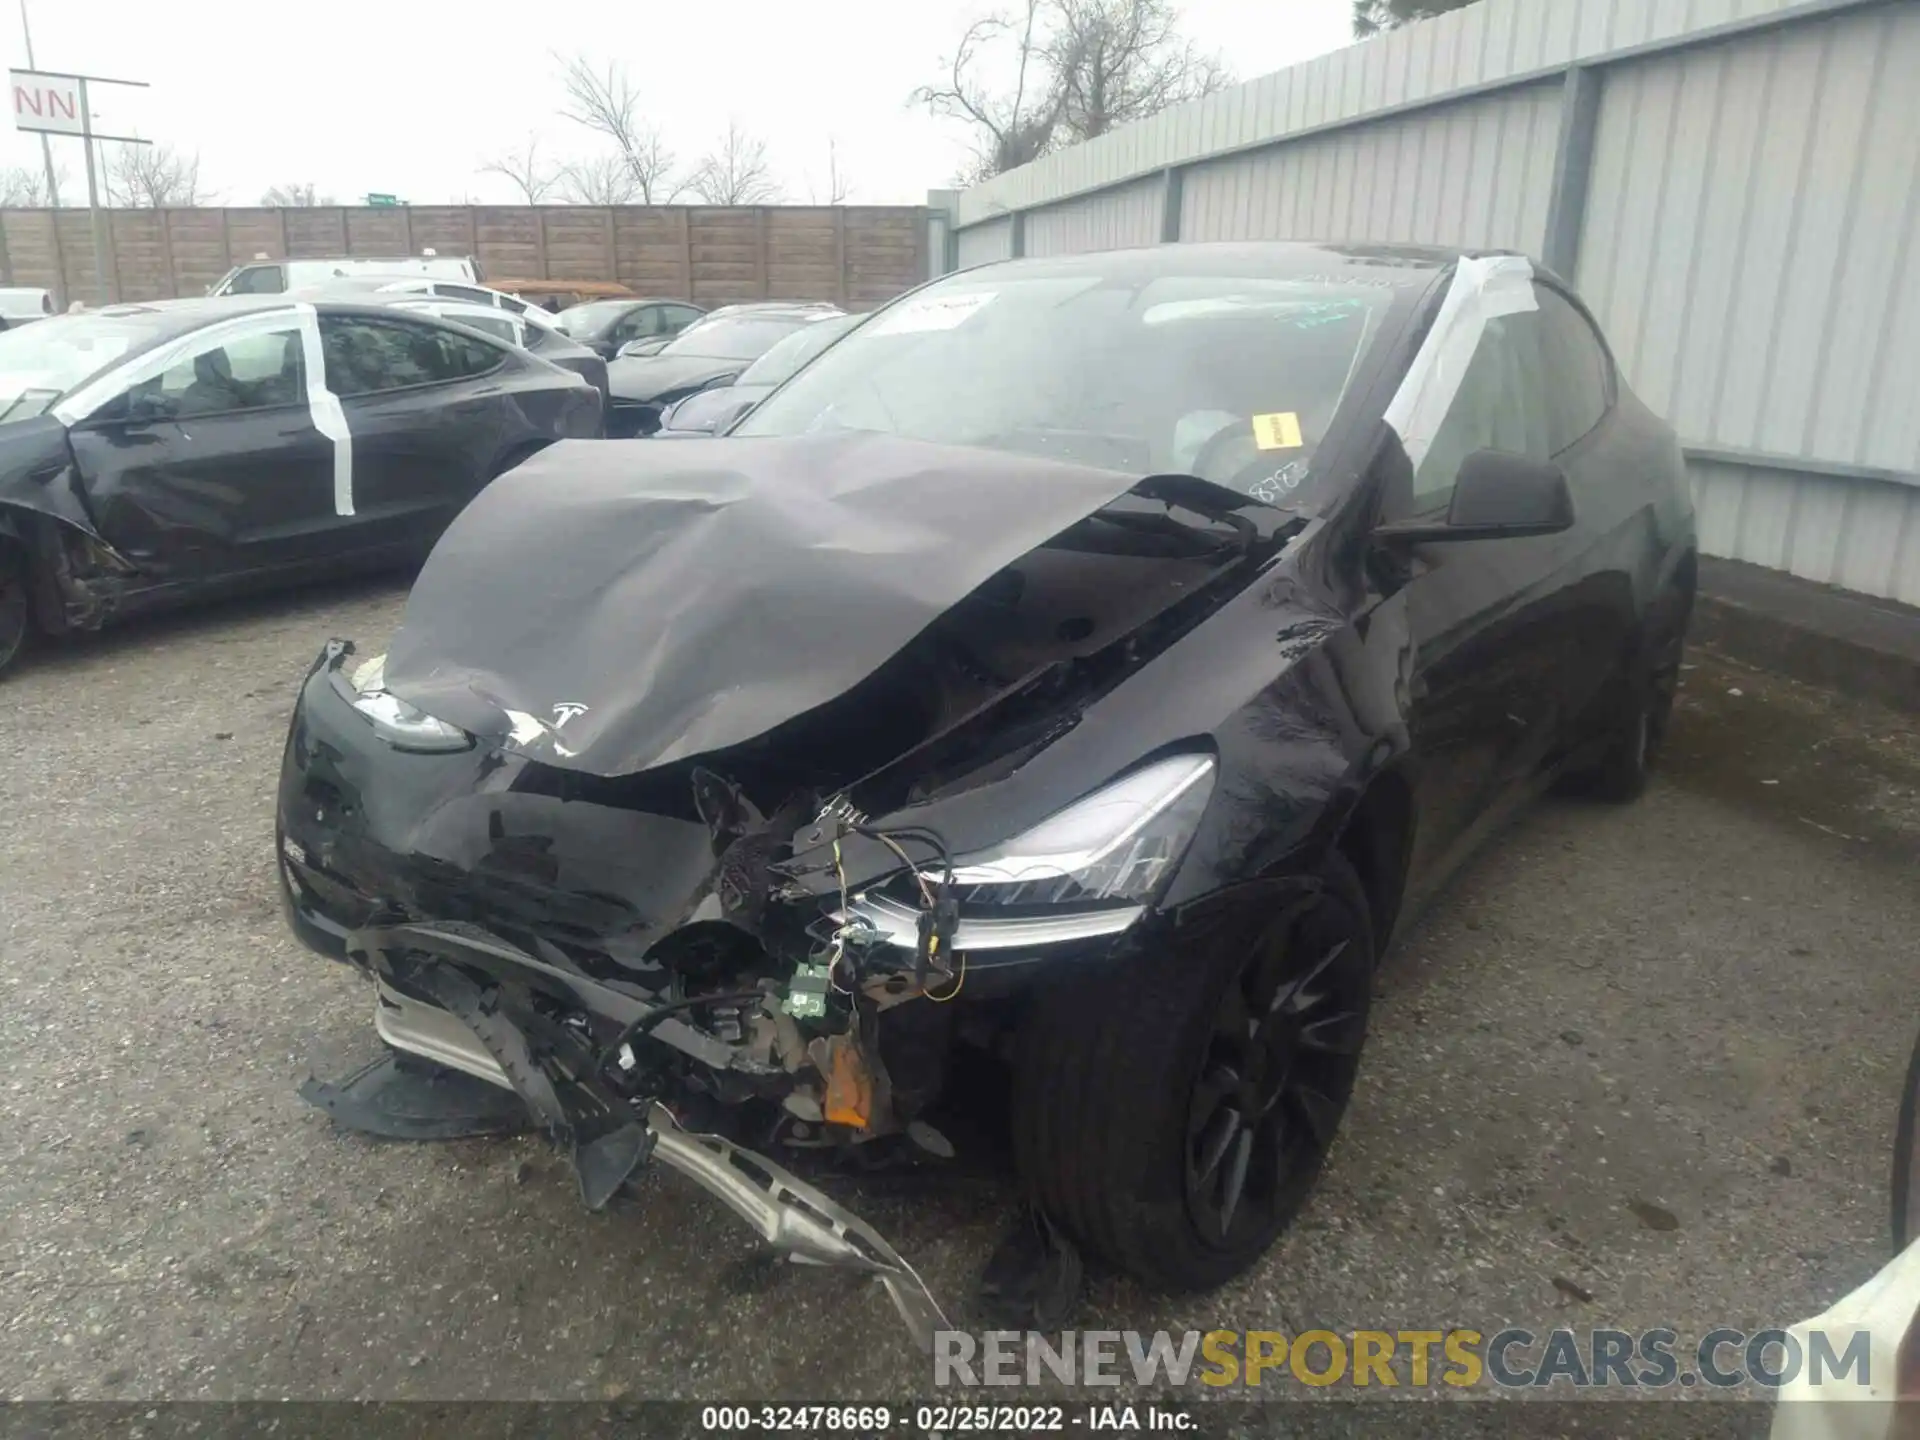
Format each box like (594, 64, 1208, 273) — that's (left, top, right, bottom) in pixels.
(733, 271, 1392, 501)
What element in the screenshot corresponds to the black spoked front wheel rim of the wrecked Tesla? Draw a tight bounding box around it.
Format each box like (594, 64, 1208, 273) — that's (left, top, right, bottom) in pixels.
(1185, 897, 1373, 1248)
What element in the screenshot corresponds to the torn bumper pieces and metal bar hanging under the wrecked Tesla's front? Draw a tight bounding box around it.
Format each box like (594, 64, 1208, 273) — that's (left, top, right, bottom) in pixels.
(346, 925, 950, 1352)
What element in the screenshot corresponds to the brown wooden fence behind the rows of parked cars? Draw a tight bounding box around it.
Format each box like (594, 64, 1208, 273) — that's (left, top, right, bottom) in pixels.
(0, 205, 927, 309)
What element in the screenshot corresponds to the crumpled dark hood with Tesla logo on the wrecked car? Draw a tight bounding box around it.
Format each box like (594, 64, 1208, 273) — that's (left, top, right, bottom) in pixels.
(386, 434, 1137, 776)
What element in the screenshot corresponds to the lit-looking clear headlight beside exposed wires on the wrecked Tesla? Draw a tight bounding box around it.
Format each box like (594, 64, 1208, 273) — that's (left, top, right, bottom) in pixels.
(927, 755, 1215, 906)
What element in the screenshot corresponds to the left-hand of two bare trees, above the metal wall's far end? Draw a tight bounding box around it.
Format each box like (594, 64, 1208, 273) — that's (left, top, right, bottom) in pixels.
(912, 0, 1066, 180)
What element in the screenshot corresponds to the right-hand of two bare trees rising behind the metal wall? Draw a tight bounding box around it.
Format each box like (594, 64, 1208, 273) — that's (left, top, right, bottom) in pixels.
(1043, 0, 1229, 140)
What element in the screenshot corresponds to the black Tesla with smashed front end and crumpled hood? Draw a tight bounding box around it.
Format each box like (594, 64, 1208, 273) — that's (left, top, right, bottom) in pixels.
(278, 244, 1693, 1338)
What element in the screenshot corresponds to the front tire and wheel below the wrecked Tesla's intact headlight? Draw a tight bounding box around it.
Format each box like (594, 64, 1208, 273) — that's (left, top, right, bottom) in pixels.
(1014, 858, 1375, 1290)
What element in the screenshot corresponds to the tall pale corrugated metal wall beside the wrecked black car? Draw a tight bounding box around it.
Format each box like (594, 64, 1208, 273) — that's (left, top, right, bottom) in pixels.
(952, 0, 1920, 605)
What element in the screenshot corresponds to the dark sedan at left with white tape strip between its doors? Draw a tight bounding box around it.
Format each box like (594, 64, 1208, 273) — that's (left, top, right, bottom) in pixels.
(0, 296, 603, 668)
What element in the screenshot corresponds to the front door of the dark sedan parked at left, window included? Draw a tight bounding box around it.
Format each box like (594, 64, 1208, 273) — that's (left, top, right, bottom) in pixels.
(60, 309, 337, 580)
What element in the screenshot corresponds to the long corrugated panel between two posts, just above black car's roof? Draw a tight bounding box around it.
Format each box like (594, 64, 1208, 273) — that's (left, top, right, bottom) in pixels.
(1181, 83, 1561, 252)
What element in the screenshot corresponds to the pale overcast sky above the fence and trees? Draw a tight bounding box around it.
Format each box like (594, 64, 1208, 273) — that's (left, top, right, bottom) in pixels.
(0, 0, 1350, 205)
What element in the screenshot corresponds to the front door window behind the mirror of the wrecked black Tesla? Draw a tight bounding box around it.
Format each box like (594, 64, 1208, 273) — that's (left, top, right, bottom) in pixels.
(1411, 313, 1553, 515)
